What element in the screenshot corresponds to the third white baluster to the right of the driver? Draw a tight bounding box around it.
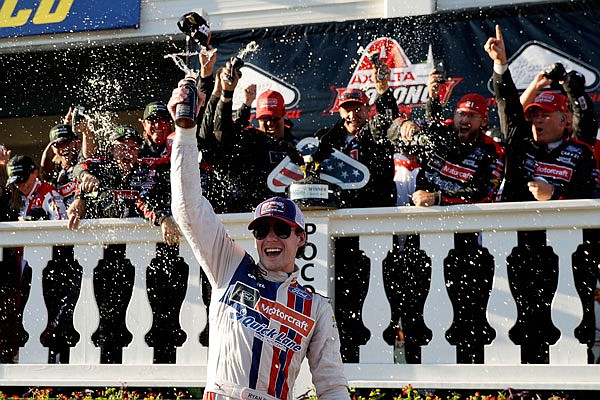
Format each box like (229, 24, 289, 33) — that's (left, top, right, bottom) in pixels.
(482, 231, 521, 364)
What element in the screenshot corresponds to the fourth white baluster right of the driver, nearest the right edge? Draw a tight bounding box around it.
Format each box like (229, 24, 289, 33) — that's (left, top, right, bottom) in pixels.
(546, 229, 587, 364)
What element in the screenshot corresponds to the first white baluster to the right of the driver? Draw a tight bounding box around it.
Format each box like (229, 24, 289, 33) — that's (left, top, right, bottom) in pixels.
(360, 235, 394, 364)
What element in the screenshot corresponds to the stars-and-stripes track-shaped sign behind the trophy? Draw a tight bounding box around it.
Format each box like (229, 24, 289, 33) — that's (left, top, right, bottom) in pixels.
(267, 137, 371, 193)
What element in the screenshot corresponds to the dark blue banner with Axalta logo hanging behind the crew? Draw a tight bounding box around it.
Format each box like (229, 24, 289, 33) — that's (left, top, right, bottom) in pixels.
(209, 1, 600, 137)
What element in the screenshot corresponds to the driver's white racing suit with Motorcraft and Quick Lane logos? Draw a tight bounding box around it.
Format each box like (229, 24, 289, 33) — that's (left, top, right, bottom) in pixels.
(171, 127, 349, 400)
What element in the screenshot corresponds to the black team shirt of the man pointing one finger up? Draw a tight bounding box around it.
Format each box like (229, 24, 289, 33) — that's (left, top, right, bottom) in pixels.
(493, 69, 598, 201)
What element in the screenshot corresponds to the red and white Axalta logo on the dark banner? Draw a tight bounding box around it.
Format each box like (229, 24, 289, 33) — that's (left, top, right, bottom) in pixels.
(323, 37, 463, 116)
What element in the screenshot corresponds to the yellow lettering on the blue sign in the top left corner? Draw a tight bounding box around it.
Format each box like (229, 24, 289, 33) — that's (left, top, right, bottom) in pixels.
(0, 0, 74, 28)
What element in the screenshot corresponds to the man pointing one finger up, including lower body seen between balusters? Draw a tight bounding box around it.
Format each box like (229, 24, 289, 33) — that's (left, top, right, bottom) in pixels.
(484, 25, 597, 363)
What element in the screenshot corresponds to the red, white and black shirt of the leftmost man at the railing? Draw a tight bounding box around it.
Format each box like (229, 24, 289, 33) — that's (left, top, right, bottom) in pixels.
(19, 179, 67, 220)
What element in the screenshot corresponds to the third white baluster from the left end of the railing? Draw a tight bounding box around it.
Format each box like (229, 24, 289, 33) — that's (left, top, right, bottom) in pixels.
(123, 243, 156, 364)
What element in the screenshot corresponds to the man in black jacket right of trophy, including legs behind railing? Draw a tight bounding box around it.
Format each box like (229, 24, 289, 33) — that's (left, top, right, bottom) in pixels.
(319, 60, 399, 362)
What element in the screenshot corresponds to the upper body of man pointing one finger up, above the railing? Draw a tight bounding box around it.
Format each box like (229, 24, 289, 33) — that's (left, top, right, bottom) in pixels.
(484, 23, 597, 201)
